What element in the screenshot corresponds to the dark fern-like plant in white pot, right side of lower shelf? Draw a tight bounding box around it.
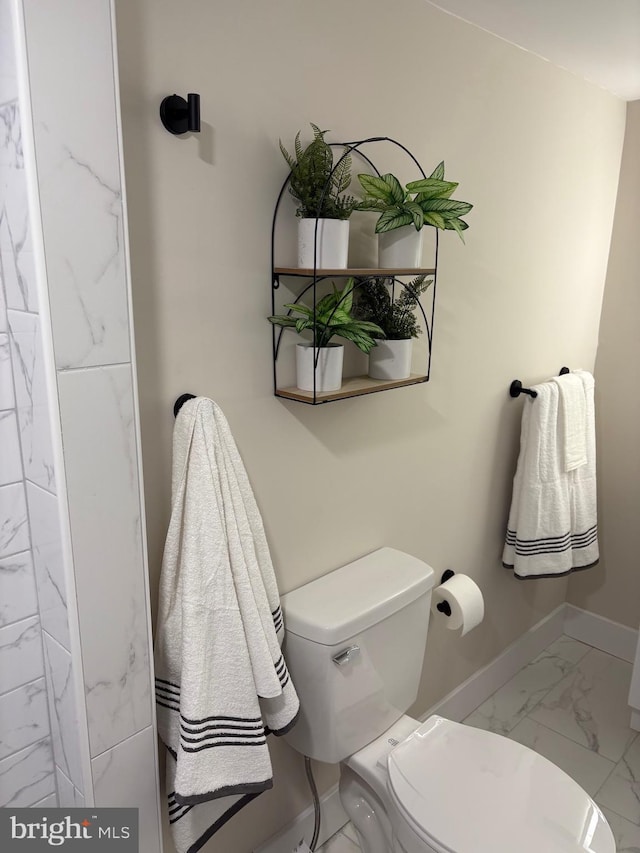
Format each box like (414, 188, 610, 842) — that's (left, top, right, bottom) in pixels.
(353, 275, 433, 380)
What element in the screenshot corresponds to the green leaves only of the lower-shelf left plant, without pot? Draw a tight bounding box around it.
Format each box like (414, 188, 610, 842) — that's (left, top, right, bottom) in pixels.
(269, 277, 384, 353)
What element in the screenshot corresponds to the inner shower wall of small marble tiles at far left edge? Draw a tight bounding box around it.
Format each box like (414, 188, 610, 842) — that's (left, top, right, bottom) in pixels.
(0, 0, 59, 807)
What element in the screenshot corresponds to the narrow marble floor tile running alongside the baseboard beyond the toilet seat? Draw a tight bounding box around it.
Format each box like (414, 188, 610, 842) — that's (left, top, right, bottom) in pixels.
(464, 644, 576, 734)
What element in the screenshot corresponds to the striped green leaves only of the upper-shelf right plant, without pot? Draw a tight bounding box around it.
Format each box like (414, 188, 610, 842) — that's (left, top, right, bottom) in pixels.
(356, 161, 473, 243)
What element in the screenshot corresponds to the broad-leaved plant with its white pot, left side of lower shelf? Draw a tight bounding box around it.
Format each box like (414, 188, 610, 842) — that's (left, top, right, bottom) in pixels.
(269, 278, 384, 394)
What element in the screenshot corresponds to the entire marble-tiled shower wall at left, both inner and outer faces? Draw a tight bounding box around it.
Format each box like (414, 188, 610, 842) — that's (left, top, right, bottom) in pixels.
(0, 0, 161, 853)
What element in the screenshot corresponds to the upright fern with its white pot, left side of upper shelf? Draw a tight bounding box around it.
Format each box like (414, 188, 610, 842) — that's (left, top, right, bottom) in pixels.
(280, 124, 357, 269)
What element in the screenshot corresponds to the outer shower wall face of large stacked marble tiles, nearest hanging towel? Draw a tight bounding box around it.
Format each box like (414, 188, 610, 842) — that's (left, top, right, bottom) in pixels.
(19, 0, 161, 853)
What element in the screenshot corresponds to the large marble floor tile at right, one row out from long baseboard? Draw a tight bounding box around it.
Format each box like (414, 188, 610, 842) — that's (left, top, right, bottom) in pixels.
(530, 649, 636, 761)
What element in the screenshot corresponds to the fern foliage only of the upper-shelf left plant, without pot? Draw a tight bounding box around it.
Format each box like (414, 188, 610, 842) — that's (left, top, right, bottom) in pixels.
(280, 124, 357, 219)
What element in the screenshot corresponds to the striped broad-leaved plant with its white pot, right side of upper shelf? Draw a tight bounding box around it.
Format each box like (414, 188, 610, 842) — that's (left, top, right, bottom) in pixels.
(356, 161, 473, 269)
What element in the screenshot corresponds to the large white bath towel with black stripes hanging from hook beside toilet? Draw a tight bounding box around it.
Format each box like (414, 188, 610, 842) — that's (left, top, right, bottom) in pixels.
(155, 397, 299, 853)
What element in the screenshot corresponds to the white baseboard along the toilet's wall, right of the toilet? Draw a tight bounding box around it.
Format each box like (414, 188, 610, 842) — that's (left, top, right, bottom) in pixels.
(421, 604, 565, 722)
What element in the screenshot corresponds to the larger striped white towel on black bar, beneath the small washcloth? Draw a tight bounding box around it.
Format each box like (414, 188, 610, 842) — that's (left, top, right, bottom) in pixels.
(502, 371, 599, 578)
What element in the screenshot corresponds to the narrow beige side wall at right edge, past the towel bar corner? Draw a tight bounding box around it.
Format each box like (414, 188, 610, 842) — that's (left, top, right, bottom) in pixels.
(569, 101, 640, 628)
